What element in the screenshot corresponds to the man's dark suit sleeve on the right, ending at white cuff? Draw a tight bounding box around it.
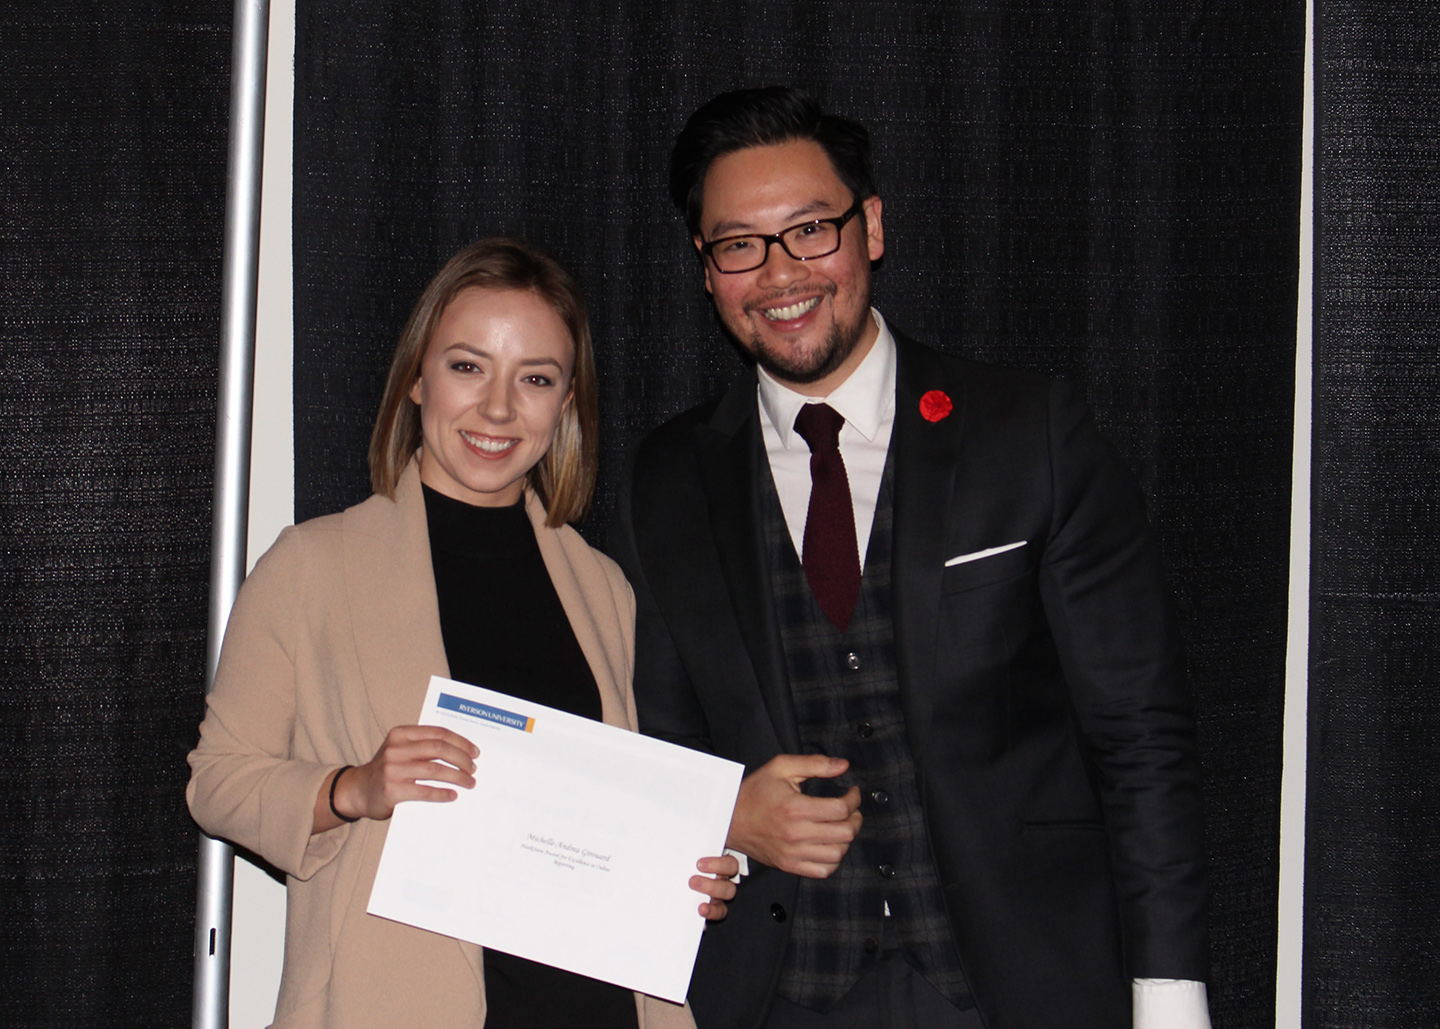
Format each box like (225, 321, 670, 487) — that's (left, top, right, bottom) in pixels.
(1038, 383, 1208, 979)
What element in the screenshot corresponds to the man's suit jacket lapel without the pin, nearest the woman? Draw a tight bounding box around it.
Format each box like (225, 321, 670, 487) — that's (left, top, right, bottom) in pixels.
(696, 371, 799, 754)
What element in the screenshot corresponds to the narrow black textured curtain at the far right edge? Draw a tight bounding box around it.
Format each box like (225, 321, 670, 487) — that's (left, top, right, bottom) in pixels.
(1305, 0, 1440, 1029)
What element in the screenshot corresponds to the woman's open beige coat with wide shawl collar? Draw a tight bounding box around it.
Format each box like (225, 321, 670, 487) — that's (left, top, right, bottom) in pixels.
(186, 463, 698, 1029)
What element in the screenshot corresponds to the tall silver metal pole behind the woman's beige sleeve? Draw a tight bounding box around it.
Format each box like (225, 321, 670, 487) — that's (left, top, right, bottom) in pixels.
(190, 0, 269, 1029)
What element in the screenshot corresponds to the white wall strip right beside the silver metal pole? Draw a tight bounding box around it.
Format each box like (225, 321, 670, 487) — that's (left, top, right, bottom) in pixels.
(230, 0, 295, 1029)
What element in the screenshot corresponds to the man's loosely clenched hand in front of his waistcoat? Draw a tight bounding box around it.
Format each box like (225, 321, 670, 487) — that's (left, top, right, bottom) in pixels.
(726, 754, 861, 879)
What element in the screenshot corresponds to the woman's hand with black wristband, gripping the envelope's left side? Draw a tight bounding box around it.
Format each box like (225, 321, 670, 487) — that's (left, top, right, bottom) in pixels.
(312, 725, 480, 832)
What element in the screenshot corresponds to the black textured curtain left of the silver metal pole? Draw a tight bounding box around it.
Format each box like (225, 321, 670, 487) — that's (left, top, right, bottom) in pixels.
(0, 0, 230, 1029)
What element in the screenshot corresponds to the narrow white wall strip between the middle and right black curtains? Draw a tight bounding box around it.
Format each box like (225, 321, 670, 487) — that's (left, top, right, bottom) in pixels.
(1274, 0, 1315, 1029)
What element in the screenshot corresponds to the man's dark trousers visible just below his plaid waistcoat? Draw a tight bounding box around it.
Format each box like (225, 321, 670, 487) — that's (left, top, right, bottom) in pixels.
(765, 950, 985, 1029)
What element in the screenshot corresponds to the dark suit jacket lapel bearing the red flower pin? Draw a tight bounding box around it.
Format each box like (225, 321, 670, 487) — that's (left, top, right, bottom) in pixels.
(890, 332, 965, 763)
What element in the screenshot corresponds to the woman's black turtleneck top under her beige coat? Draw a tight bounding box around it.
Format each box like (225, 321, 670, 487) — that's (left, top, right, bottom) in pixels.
(425, 486, 636, 1029)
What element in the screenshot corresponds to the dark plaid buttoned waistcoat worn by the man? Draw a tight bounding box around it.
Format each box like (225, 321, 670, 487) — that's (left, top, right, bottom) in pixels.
(760, 453, 972, 1012)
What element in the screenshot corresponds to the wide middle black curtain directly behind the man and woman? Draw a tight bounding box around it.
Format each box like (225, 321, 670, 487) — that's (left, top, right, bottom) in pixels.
(294, 0, 1303, 1029)
